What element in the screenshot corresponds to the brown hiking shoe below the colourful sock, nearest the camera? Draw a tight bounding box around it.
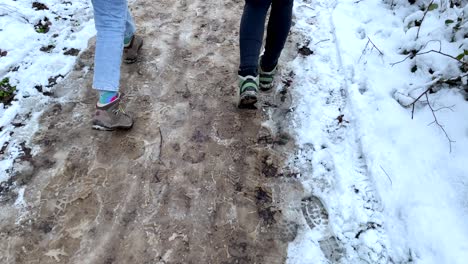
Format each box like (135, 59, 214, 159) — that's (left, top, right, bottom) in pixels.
(93, 93, 133, 131)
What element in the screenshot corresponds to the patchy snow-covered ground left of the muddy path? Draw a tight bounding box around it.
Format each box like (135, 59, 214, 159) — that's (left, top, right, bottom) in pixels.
(0, 0, 95, 182)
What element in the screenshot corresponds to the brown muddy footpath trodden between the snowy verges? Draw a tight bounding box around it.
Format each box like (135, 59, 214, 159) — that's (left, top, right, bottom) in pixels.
(0, 0, 302, 264)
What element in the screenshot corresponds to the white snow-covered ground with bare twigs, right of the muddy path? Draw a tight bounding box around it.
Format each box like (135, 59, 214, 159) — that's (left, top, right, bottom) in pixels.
(289, 0, 468, 263)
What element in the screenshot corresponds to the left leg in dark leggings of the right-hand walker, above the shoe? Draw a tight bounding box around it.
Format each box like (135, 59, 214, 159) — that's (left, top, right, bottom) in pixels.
(239, 0, 272, 76)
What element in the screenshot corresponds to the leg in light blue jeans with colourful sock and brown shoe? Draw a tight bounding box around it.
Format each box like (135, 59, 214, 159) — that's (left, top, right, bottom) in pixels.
(92, 0, 135, 130)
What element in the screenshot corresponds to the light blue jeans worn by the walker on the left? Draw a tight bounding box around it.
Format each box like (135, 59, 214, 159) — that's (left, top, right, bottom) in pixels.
(91, 0, 135, 92)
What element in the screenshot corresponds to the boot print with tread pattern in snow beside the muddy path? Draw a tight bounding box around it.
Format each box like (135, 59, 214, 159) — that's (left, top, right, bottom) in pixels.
(302, 196, 344, 263)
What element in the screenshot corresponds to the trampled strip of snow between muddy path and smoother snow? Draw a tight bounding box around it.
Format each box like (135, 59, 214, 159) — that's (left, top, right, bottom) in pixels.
(289, 0, 389, 263)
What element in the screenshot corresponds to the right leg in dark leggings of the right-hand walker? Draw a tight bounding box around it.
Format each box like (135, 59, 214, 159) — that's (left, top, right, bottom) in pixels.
(261, 0, 294, 72)
